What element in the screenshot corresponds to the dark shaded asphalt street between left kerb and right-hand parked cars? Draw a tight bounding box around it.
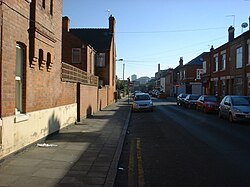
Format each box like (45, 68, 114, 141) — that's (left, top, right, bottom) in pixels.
(115, 99, 250, 187)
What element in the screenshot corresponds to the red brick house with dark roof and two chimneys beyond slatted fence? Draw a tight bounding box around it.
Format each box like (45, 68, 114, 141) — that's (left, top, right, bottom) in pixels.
(62, 16, 116, 104)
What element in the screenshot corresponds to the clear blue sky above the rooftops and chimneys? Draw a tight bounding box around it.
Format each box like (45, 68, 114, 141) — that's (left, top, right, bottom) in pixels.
(63, 0, 250, 79)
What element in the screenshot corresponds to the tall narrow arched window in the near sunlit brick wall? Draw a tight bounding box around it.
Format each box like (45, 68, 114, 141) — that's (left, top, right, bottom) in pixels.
(16, 44, 24, 114)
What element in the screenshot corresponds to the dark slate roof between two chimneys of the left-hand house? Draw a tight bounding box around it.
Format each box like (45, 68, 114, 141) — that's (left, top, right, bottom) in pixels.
(69, 28, 112, 52)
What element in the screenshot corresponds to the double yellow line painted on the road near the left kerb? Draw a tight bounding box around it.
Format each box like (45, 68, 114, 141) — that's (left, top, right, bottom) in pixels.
(128, 138, 145, 187)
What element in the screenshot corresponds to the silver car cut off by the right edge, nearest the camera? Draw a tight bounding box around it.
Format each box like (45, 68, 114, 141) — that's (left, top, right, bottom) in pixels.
(219, 95, 250, 122)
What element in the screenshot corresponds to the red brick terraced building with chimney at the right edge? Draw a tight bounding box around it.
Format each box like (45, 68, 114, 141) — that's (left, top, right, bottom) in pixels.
(202, 26, 250, 97)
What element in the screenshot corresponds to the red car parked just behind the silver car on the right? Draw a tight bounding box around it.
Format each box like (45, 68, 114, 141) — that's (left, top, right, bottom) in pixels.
(196, 95, 220, 113)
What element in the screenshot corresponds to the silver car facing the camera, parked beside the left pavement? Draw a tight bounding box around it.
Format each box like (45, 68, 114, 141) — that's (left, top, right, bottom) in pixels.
(132, 93, 153, 111)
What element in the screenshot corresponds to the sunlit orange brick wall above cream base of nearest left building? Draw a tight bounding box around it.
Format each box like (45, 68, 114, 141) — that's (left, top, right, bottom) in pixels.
(0, 0, 76, 116)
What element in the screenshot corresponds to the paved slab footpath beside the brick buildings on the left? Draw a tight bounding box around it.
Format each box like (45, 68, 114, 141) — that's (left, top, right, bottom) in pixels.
(0, 99, 131, 187)
